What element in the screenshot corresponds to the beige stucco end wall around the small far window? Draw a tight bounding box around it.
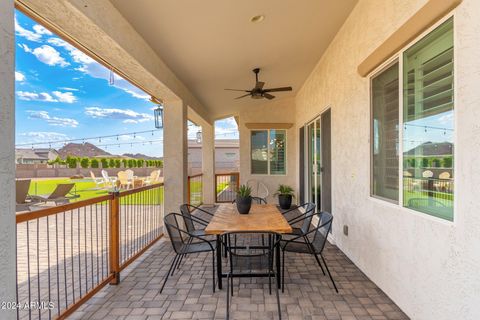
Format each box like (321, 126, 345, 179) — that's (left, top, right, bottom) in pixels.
(238, 97, 297, 203)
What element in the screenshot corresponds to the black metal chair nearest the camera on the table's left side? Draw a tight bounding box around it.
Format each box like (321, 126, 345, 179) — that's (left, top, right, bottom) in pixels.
(160, 213, 216, 293)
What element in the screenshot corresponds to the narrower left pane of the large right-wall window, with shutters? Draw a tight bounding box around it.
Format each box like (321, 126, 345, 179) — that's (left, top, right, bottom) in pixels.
(371, 62, 399, 203)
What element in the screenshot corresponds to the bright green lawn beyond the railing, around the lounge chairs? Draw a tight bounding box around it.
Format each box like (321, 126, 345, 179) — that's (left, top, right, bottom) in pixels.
(29, 178, 163, 204)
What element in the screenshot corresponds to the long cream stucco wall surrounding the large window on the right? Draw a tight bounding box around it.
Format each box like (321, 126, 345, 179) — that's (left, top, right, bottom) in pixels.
(296, 0, 480, 320)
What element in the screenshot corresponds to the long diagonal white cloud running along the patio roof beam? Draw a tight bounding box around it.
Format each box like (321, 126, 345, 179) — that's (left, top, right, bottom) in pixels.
(47, 38, 150, 100)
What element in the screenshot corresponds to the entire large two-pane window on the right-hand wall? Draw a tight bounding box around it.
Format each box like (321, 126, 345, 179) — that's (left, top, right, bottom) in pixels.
(371, 18, 454, 221)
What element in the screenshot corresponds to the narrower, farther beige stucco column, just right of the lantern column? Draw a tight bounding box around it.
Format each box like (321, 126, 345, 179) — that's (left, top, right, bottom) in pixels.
(202, 123, 215, 204)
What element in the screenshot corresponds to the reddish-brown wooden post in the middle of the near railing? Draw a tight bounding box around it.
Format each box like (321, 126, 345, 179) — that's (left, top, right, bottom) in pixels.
(110, 191, 120, 285)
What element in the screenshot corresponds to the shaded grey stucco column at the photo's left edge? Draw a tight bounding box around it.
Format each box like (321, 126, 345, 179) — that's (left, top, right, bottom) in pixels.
(0, 0, 16, 320)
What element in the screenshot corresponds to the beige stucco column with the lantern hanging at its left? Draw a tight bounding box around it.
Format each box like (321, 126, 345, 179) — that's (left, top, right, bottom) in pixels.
(163, 100, 188, 218)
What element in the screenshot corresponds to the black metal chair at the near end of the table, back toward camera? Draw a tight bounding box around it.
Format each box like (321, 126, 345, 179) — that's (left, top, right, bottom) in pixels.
(223, 231, 282, 319)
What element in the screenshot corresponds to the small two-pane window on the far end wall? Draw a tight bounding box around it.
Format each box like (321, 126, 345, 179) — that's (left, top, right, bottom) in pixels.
(251, 129, 286, 175)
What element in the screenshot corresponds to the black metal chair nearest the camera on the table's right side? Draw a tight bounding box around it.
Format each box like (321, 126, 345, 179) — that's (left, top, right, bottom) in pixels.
(280, 212, 338, 293)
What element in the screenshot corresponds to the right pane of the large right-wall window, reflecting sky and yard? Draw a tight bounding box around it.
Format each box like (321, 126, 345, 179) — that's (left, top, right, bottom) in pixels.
(403, 19, 454, 220)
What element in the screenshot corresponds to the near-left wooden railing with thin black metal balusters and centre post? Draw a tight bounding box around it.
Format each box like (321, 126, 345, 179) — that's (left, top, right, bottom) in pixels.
(15, 183, 163, 319)
